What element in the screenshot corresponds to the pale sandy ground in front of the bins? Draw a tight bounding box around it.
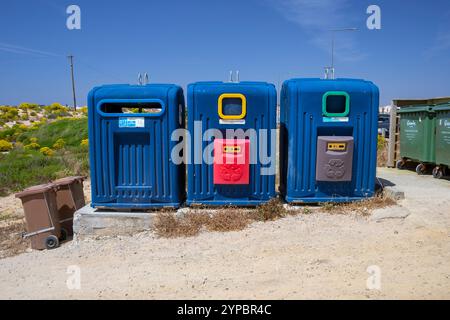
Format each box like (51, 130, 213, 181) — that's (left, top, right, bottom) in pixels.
(0, 169, 450, 299)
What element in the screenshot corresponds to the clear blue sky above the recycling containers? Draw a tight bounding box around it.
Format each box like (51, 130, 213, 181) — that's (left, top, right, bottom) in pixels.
(0, 0, 450, 105)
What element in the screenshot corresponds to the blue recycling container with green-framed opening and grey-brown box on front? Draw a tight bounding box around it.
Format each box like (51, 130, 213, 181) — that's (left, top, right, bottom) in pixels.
(280, 79, 379, 203)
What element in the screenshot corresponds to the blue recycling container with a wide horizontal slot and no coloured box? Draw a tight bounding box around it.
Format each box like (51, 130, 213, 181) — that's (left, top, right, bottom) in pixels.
(88, 84, 185, 209)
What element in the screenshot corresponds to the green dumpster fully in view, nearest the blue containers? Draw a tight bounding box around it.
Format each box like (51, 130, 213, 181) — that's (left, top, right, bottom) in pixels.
(397, 106, 436, 174)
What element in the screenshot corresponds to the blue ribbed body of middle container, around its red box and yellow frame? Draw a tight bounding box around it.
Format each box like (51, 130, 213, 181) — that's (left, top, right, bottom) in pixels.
(187, 82, 276, 206)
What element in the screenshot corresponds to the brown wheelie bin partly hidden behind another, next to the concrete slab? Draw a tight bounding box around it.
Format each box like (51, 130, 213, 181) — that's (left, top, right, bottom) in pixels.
(53, 177, 85, 240)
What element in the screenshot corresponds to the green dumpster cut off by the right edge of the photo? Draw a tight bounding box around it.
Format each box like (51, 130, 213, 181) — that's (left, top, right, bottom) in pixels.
(433, 103, 450, 179)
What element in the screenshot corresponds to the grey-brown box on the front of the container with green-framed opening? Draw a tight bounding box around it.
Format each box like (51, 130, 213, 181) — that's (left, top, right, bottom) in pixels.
(316, 136, 354, 182)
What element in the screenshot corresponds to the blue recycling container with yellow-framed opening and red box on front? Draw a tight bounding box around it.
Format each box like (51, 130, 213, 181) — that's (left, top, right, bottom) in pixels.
(187, 82, 277, 206)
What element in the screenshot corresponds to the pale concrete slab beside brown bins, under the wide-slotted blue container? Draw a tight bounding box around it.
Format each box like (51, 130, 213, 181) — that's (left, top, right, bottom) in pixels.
(73, 205, 156, 239)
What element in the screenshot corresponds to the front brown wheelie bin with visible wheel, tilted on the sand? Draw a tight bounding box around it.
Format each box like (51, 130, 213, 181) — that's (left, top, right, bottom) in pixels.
(16, 184, 61, 250)
